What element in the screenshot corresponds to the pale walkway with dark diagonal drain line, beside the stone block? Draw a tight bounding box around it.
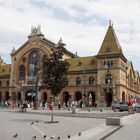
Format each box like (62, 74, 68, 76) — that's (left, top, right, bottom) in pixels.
(65, 113, 140, 140)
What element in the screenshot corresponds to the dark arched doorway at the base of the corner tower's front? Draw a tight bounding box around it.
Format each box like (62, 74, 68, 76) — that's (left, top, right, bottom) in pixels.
(105, 89, 112, 107)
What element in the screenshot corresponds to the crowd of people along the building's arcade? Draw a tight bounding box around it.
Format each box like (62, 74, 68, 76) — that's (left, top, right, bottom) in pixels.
(0, 99, 97, 111)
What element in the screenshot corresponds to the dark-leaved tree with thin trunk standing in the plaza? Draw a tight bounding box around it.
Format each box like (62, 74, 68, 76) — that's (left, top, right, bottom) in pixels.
(44, 40, 69, 122)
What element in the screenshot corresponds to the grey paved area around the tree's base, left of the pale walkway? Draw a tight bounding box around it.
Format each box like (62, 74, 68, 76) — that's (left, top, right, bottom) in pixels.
(0, 110, 105, 140)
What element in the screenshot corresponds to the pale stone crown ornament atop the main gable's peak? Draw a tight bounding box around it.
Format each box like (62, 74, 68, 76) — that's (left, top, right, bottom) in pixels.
(28, 25, 44, 38)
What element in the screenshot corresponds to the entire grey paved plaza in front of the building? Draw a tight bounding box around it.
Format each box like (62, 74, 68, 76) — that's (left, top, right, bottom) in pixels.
(0, 109, 140, 140)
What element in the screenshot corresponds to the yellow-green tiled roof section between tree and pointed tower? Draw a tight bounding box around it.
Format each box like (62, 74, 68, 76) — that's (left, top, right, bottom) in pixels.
(67, 56, 97, 71)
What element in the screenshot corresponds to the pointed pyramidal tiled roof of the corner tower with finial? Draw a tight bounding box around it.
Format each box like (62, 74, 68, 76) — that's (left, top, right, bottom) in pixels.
(98, 20, 122, 55)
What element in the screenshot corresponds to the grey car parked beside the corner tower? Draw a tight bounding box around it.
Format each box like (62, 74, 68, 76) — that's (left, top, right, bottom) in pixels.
(112, 101, 128, 111)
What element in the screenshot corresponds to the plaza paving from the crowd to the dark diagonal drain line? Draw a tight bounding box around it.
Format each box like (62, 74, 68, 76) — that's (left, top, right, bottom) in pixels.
(0, 109, 131, 140)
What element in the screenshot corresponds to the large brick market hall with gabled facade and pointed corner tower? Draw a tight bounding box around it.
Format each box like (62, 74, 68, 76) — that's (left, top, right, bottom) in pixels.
(0, 23, 140, 107)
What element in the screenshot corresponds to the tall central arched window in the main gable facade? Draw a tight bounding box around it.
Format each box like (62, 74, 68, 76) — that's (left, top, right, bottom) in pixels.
(29, 50, 39, 76)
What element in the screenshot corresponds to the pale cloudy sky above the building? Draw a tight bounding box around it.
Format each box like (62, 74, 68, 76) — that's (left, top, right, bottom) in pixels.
(0, 0, 140, 71)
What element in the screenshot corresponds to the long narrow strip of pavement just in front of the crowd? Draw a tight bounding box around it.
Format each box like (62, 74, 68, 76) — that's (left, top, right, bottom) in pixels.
(1, 108, 129, 119)
